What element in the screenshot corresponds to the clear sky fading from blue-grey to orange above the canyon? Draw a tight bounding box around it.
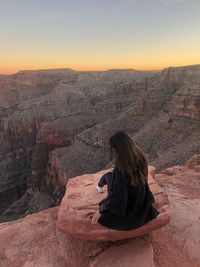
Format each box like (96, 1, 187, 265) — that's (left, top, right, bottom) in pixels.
(0, 0, 200, 73)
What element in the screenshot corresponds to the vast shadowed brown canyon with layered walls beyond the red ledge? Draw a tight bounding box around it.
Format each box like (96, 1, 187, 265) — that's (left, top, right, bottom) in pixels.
(0, 65, 200, 222)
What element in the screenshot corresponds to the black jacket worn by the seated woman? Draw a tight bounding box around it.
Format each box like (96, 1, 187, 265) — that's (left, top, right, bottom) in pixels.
(98, 167, 159, 230)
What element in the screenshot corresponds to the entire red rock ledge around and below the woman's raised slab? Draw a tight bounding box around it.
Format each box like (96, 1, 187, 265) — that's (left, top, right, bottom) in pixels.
(0, 155, 200, 267)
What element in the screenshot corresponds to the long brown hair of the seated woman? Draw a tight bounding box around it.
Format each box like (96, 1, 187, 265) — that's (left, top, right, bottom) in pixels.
(109, 131, 148, 186)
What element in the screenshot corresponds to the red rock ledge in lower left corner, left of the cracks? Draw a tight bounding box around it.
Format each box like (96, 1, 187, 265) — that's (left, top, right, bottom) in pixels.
(0, 208, 108, 267)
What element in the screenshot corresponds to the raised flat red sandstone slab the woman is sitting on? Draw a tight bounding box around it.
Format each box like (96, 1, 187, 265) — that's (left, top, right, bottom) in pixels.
(57, 167, 170, 240)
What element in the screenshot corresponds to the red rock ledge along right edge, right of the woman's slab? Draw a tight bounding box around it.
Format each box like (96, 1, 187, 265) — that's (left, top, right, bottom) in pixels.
(152, 167, 200, 267)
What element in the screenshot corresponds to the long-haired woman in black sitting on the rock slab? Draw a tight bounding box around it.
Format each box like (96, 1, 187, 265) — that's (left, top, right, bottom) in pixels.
(91, 131, 159, 230)
